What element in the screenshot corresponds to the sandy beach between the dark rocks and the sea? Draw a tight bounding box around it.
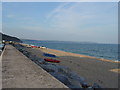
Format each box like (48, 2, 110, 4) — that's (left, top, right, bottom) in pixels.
(18, 43, 119, 88)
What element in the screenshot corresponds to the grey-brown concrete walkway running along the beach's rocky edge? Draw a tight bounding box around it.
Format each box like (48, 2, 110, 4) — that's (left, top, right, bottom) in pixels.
(2, 45, 67, 88)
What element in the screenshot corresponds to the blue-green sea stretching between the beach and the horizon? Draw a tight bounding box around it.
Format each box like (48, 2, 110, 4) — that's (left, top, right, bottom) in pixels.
(22, 39, 120, 61)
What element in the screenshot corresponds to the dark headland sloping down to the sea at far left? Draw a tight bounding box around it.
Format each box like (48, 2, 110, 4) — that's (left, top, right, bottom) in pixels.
(0, 33, 22, 42)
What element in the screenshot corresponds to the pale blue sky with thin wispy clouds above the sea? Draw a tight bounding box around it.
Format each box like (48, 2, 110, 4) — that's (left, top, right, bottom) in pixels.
(2, 2, 118, 44)
